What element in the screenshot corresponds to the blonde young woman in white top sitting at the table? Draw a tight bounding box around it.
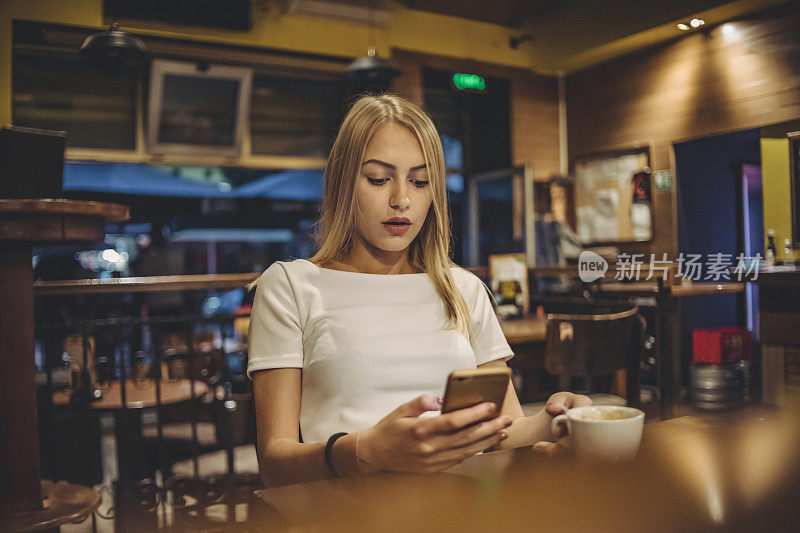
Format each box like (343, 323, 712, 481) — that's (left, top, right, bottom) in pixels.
(248, 95, 591, 486)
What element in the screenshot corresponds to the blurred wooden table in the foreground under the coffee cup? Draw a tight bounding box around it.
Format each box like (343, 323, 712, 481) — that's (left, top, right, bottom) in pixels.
(257, 417, 800, 531)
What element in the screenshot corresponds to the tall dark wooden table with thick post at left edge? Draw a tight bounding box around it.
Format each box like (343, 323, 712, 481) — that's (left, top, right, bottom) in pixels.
(0, 197, 129, 514)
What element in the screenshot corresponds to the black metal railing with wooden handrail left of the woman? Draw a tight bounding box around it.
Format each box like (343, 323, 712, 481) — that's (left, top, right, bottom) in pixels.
(36, 275, 261, 531)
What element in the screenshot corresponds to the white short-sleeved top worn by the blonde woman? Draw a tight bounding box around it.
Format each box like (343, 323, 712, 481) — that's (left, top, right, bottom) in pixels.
(247, 259, 513, 442)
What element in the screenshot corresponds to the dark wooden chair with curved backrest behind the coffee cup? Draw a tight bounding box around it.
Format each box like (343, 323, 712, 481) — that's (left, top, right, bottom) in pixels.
(545, 302, 646, 406)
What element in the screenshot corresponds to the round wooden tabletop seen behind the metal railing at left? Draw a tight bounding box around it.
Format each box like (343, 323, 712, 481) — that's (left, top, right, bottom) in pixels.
(53, 379, 210, 410)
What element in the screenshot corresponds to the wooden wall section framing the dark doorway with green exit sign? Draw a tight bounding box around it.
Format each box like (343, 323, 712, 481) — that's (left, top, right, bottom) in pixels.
(392, 50, 559, 178)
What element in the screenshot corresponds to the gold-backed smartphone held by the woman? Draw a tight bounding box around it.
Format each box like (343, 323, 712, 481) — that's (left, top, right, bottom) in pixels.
(442, 367, 511, 416)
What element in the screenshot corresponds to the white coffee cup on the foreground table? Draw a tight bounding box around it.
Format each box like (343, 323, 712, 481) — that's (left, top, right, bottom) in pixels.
(551, 405, 644, 461)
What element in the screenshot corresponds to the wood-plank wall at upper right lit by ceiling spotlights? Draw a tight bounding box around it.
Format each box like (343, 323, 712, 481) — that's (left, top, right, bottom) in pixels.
(566, 2, 800, 253)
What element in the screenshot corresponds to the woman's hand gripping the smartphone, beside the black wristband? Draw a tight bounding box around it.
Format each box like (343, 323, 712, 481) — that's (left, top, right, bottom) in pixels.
(356, 394, 512, 473)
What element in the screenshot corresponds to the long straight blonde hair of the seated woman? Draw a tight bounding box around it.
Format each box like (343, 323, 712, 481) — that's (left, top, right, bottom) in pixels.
(311, 94, 472, 338)
